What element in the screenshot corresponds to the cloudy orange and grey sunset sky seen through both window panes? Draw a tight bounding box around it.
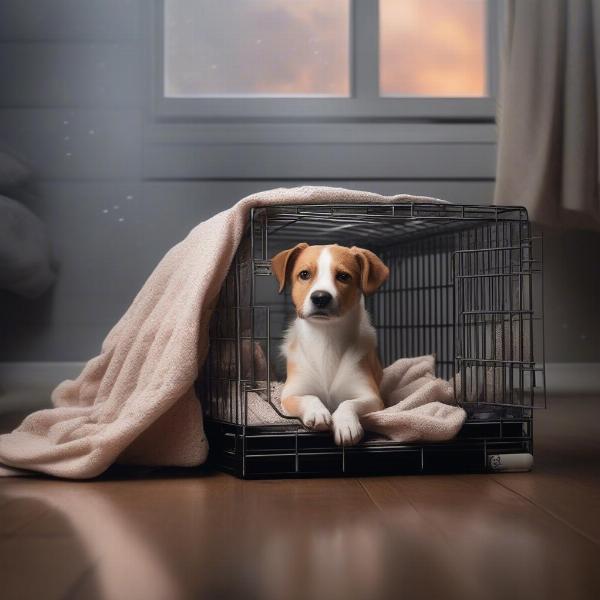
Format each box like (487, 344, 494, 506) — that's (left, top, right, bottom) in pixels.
(165, 0, 485, 97)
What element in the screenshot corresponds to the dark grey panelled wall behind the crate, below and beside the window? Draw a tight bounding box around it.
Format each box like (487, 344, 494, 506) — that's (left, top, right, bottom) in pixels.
(0, 0, 600, 362)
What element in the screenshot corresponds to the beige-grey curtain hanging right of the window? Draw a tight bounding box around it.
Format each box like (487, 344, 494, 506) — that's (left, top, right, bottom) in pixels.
(495, 0, 600, 229)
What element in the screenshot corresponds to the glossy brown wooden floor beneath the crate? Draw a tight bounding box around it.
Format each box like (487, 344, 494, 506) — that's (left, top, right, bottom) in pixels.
(0, 398, 600, 600)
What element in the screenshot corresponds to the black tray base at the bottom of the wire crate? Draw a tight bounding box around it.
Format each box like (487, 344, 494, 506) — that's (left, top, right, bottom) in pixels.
(206, 418, 531, 479)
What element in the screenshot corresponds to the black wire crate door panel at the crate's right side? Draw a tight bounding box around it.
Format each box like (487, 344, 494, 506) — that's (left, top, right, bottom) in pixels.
(452, 230, 546, 407)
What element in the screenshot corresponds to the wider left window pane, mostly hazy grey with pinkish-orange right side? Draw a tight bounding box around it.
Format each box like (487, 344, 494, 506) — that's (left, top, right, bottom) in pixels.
(165, 0, 350, 97)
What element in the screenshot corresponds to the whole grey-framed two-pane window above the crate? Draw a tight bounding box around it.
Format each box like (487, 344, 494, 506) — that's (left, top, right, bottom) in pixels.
(155, 0, 498, 120)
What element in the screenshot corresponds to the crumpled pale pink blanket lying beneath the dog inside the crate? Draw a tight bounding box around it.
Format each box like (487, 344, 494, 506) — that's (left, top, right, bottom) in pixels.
(248, 355, 466, 442)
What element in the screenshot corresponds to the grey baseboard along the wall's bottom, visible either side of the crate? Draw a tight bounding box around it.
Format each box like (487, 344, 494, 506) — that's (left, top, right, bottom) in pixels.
(0, 362, 600, 412)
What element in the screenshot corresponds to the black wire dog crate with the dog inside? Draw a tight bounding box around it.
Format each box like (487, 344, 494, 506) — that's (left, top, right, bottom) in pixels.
(198, 202, 546, 478)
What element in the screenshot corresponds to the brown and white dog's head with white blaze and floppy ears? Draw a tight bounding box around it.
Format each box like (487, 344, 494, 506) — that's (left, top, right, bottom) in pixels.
(271, 243, 389, 321)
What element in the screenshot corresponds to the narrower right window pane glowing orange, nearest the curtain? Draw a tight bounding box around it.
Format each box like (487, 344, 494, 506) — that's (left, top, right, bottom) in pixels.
(379, 0, 486, 96)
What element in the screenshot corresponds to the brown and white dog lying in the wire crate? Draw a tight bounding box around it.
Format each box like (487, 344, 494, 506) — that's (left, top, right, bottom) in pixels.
(272, 243, 389, 446)
